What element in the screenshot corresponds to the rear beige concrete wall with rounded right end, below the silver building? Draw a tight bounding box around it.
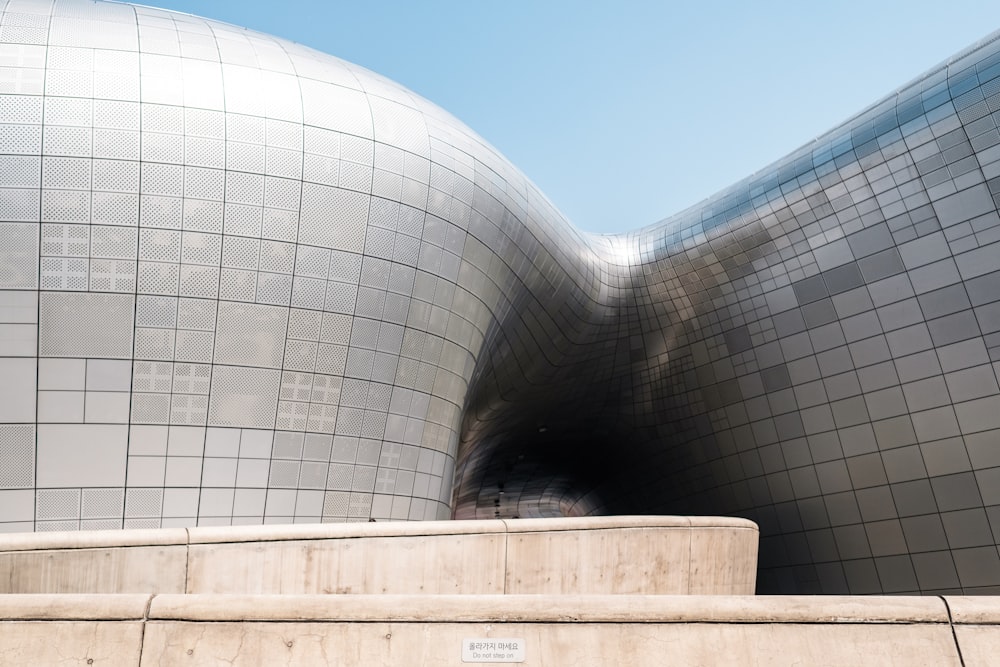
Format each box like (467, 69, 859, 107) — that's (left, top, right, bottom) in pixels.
(0, 516, 758, 595)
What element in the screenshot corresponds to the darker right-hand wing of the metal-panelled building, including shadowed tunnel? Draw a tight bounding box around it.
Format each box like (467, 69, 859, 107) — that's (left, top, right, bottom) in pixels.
(456, 32, 1000, 594)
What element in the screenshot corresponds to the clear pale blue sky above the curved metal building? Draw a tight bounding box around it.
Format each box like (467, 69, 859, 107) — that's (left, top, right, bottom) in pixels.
(135, 0, 1000, 233)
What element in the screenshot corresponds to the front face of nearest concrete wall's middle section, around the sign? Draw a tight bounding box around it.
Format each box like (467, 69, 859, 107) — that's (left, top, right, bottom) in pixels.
(142, 621, 961, 667)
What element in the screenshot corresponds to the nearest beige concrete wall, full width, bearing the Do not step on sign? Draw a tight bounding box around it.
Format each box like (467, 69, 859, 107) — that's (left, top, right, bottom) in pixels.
(0, 594, 1000, 667)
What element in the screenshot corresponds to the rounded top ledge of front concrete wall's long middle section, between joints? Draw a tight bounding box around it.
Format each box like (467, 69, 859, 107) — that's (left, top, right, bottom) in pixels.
(149, 594, 948, 624)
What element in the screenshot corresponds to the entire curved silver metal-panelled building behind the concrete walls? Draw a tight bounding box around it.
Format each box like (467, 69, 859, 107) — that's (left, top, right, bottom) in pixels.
(0, 0, 1000, 593)
